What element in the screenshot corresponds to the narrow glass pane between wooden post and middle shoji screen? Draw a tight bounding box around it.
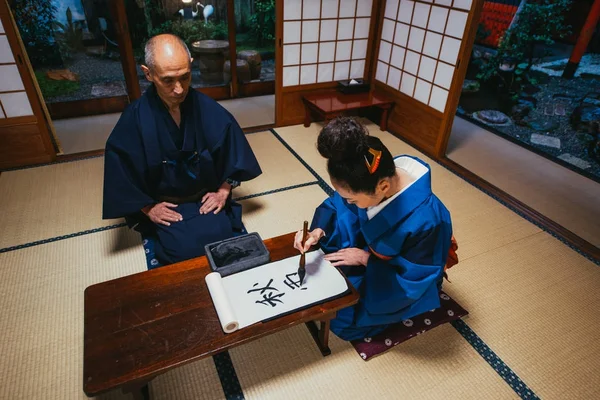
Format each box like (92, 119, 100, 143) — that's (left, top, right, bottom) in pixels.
(234, 0, 275, 82)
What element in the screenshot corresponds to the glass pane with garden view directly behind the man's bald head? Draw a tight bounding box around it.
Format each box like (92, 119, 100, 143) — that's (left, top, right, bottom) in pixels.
(125, 0, 230, 91)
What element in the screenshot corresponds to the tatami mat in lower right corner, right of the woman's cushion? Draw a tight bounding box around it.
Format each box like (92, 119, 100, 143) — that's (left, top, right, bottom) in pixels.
(445, 232, 600, 399)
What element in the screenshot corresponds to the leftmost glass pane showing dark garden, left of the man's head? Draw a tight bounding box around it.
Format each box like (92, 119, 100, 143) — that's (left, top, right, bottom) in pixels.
(11, 0, 127, 103)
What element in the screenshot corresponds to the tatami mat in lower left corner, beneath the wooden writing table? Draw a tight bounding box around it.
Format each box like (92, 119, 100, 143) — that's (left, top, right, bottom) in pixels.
(0, 228, 223, 400)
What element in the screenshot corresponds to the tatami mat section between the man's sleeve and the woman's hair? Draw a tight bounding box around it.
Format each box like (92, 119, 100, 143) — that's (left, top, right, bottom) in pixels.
(234, 131, 315, 197)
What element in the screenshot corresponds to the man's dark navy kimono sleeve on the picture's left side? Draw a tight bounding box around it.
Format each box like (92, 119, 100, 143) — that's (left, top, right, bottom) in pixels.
(102, 108, 154, 219)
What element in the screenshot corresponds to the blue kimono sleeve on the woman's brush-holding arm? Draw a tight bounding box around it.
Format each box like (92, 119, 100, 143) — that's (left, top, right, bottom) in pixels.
(310, 192, 364, 253)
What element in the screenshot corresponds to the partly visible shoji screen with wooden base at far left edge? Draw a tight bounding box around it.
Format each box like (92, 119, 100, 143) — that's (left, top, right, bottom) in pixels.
(0, 1, 56, 168)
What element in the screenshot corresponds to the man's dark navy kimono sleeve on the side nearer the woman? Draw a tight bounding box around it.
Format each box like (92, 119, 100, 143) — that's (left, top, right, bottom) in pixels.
(212, 117, 262, 183)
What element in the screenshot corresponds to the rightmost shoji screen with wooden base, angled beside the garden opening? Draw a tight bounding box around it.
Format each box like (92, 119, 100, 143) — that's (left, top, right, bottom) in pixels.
(374, 0, 482, 154)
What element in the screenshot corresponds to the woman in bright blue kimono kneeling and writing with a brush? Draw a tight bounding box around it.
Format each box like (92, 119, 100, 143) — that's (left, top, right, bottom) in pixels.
(294, 118, 452, 340)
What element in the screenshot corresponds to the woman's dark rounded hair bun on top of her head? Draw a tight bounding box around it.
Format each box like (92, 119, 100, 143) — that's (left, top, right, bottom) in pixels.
(317, 117, 369, 161)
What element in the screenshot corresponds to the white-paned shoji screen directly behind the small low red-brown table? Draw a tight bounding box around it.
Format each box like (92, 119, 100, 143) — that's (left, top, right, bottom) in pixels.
(276, 0, 375, 125)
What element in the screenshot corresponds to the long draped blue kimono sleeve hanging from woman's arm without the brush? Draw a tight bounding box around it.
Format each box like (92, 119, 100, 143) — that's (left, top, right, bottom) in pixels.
(357, 211, 452, 326)
